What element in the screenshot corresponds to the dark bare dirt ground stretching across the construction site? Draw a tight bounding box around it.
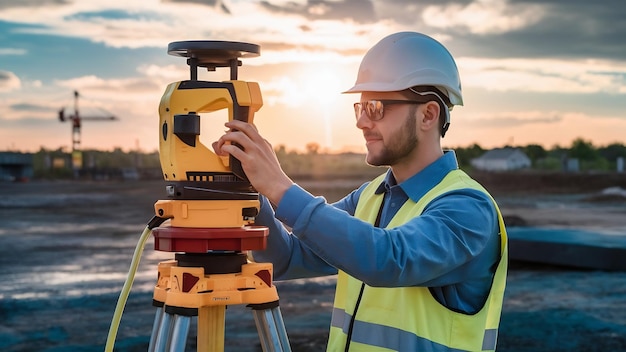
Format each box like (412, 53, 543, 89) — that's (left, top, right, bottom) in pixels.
(0, 177, 626, 352)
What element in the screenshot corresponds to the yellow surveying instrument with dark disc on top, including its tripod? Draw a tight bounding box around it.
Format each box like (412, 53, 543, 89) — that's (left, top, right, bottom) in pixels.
(109, 41, 291, 352)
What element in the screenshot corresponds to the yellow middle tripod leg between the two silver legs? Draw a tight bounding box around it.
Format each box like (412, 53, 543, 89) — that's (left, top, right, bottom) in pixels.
(198, 306, 226, 352)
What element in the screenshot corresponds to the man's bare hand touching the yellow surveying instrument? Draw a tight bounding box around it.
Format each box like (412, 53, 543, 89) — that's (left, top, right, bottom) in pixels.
(213, 120, 293, 205)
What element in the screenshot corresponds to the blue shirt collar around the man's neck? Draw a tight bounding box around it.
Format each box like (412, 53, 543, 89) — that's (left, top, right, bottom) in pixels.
(375, 150, 459, 202)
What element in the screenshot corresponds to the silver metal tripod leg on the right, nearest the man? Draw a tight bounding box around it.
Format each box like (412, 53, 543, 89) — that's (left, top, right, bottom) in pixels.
(253, 306, 291, 352)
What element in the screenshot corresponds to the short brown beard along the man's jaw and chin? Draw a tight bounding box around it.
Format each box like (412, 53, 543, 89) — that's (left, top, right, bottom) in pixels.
(366, 109, 418, 166)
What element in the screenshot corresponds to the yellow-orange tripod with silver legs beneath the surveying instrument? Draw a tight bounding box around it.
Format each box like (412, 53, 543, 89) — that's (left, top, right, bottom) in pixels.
(148, 253, 291, 351)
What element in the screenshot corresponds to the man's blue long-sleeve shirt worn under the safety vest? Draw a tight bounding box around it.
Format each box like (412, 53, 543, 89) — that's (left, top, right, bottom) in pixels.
(253, 151, 500, 313)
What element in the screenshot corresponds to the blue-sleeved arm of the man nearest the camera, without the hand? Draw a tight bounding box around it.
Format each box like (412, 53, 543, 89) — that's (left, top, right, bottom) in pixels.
(276, 186, 499, 287)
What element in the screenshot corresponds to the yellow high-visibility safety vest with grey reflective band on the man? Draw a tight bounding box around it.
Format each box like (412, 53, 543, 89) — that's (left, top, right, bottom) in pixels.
(328, 170, 508, 352)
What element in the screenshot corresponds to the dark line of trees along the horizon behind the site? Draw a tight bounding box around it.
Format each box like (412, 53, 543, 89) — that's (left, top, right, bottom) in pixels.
(33, 138, 626, 178)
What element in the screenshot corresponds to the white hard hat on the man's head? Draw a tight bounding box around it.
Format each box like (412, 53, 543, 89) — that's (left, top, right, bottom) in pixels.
(344, 32, 463, 106)
